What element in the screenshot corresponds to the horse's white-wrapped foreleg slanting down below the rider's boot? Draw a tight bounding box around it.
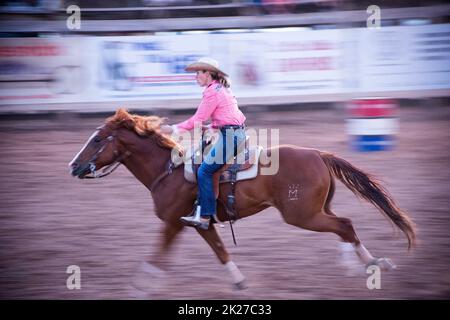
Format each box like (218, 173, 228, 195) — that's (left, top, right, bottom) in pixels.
(197, 225, 245, 289)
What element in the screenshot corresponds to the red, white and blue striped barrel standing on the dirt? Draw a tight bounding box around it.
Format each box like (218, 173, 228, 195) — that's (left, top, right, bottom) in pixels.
(347, 98, 398, 152)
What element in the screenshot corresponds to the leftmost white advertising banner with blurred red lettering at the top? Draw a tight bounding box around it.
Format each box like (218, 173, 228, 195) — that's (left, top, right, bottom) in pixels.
(0, 38, 87, 104)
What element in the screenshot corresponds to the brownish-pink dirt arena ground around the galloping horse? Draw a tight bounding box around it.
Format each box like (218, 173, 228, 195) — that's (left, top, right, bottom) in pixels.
(0, 106, 450, 299)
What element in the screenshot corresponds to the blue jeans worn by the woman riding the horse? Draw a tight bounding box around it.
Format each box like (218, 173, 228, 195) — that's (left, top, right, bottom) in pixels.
(197, 129, 245, 216)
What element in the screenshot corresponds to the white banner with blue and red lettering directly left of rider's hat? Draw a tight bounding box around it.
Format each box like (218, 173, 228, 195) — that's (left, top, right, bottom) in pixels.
(93, 34, 209, 100)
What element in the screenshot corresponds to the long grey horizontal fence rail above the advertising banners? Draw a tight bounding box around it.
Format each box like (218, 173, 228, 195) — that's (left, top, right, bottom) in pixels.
(0, 5, 450, 33)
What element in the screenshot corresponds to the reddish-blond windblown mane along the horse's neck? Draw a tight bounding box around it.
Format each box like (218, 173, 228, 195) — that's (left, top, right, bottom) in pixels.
(105, 108, 184, 155)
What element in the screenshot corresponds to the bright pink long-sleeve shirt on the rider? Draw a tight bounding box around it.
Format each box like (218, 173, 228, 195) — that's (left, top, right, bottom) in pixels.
(175, 81, 245, 130)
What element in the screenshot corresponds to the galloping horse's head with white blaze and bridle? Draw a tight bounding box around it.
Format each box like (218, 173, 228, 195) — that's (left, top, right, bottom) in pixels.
(69, 124, 125, 179)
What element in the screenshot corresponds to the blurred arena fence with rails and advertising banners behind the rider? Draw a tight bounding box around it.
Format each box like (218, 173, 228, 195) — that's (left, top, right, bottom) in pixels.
(0, 0, 450, 113)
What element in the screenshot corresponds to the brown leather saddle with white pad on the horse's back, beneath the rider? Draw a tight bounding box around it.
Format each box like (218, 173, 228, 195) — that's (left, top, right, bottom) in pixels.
(184, 137, 263, 220)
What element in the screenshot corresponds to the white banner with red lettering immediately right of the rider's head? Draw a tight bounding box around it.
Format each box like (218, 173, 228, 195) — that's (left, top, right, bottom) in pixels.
(223, 29, 341, 97)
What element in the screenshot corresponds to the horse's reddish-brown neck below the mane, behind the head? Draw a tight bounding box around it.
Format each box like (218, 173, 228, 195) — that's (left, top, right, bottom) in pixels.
(123, 146, 170, 190)
